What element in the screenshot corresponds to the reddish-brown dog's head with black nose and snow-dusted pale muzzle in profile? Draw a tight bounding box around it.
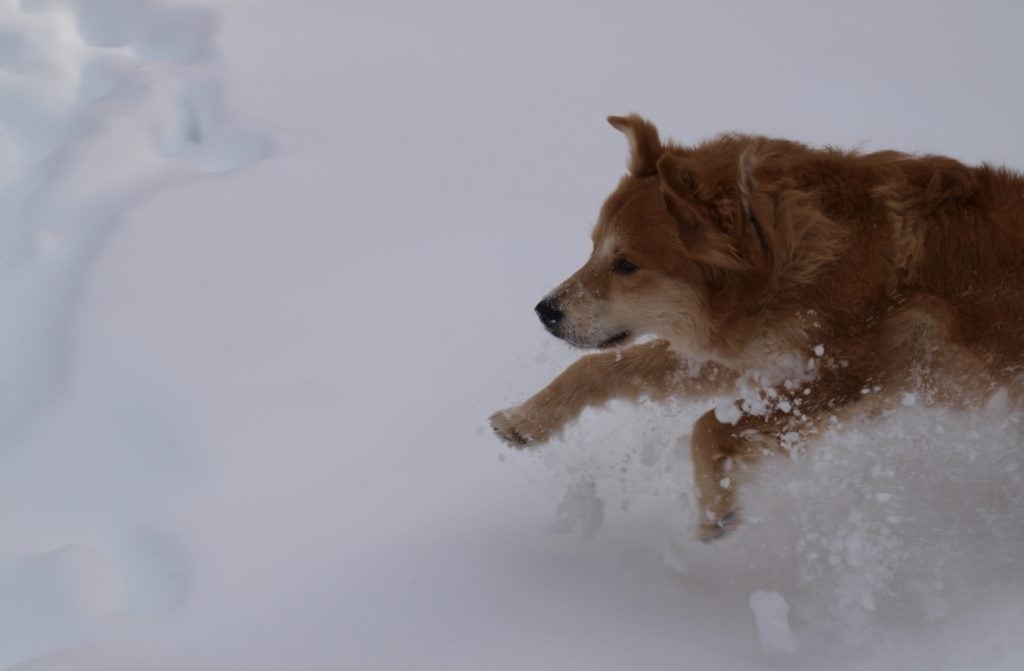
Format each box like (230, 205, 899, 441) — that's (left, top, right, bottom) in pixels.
(536, 115, 765, 353)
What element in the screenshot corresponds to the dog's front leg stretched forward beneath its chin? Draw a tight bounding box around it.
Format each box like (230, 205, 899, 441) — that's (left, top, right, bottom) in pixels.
(490, 340, 732, 447)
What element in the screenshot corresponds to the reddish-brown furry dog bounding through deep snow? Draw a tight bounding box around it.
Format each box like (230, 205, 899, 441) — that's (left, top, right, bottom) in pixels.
(490, 115, 1024, 541)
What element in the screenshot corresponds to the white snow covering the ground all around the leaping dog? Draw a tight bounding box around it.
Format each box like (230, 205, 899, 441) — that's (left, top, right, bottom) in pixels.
(6, 0, 1024, 671)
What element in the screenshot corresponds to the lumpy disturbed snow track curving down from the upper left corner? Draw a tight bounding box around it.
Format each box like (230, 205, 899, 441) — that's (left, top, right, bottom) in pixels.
(0, 0, 266, 430)
